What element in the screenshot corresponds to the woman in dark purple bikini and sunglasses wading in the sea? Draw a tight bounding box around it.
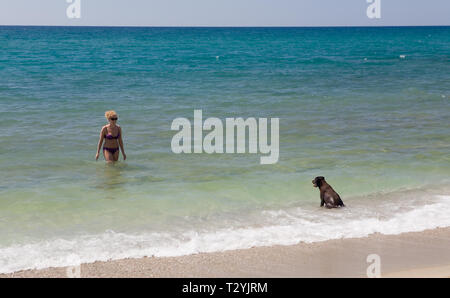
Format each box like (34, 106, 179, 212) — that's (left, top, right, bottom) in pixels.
(95, 111, 127, 162)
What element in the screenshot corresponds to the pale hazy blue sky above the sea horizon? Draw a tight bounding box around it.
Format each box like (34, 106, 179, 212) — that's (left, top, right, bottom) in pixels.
(0, 0, 450, 26)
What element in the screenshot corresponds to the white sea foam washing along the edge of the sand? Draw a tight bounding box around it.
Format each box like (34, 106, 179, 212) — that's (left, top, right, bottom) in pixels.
(0, 196, 450, 273)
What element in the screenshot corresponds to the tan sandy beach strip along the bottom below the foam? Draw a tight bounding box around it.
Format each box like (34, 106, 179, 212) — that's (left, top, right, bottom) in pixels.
(0, 228, 450, 277)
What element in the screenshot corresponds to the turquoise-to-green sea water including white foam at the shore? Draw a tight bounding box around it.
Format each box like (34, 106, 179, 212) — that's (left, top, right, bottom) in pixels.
(0, 27, 450, 272)
